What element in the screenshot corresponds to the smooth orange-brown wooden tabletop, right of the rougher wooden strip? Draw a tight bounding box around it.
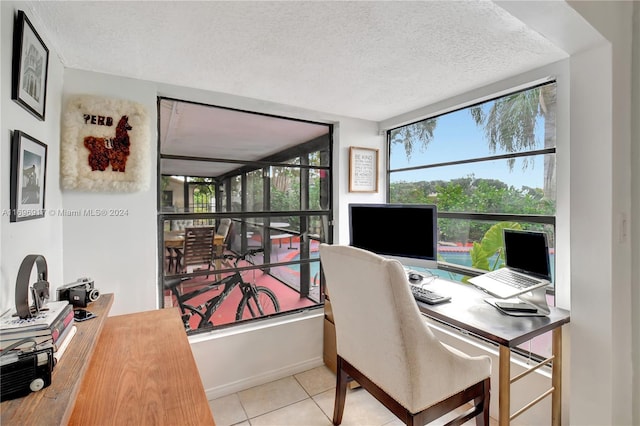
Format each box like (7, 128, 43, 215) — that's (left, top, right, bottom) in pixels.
(69, 308, 214, 425)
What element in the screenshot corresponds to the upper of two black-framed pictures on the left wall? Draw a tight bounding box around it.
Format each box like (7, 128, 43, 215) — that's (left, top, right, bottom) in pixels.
(11, 10, 49, 121)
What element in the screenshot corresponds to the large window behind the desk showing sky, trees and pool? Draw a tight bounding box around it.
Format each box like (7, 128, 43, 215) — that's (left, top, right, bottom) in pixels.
(387, 82, 556, 353)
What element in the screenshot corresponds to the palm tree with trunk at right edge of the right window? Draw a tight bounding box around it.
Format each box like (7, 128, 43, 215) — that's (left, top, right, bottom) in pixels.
(470, 84, 557, 200)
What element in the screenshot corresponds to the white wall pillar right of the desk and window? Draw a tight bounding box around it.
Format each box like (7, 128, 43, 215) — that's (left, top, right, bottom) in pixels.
(570, 2, 638, 424)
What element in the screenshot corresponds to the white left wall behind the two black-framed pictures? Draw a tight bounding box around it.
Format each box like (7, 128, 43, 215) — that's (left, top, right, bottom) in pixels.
(0, 1, 64, 312)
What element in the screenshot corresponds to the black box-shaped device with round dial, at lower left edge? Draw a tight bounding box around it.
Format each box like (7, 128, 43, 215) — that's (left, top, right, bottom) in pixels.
(0, 344, 55, 401)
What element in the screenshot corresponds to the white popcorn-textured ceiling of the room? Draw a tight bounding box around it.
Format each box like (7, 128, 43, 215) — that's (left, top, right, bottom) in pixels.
(22, 1, 566, 121)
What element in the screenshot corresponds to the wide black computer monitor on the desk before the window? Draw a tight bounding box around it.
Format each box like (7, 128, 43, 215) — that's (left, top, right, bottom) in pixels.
(349, 204, 438, 269)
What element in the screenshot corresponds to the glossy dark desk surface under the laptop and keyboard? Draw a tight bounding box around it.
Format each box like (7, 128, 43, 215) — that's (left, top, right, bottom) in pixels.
(418, 278, 570, 348)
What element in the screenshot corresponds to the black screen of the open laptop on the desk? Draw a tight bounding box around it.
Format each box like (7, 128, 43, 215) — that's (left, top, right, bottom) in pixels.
(503, 229, 551, 280)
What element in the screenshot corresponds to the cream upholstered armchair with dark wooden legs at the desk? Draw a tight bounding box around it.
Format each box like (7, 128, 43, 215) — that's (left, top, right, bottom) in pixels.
(320, 244, 491, 425)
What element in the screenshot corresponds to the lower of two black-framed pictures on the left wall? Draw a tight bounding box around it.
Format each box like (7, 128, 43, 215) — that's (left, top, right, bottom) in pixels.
(9, 130, 47, 222)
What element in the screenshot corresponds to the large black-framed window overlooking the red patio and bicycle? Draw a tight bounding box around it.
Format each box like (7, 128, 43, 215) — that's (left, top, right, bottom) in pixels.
(158, 99, 332, 334)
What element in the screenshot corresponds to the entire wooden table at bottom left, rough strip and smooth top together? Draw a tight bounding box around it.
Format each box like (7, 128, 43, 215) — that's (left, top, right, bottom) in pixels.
(0, 294, 214, 426)
